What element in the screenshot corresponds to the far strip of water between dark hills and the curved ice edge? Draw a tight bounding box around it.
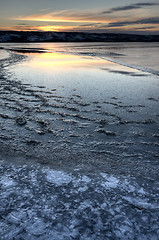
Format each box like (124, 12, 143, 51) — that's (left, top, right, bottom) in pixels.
(0, 42, 159, 74)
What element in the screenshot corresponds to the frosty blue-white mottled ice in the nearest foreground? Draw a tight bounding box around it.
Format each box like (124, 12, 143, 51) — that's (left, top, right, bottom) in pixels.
(0, 162, 159, 240)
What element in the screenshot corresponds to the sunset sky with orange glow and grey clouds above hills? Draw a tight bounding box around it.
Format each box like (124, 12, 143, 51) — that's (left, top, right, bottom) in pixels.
(0, 0, 159, 34)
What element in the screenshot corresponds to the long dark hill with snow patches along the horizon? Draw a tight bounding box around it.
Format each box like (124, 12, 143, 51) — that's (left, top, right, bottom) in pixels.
(0, 31, 159, 43)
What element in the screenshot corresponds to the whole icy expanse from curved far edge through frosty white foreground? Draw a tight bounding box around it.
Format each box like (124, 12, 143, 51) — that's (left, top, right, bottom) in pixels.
(0, 44, 159, 239)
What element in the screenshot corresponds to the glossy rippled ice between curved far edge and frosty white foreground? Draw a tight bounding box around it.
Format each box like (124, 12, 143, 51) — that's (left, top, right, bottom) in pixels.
(0, 48, 159, 178)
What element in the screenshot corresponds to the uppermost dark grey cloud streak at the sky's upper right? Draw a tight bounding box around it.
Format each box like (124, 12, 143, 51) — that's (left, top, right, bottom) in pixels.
(102, 2, 159, 14)
